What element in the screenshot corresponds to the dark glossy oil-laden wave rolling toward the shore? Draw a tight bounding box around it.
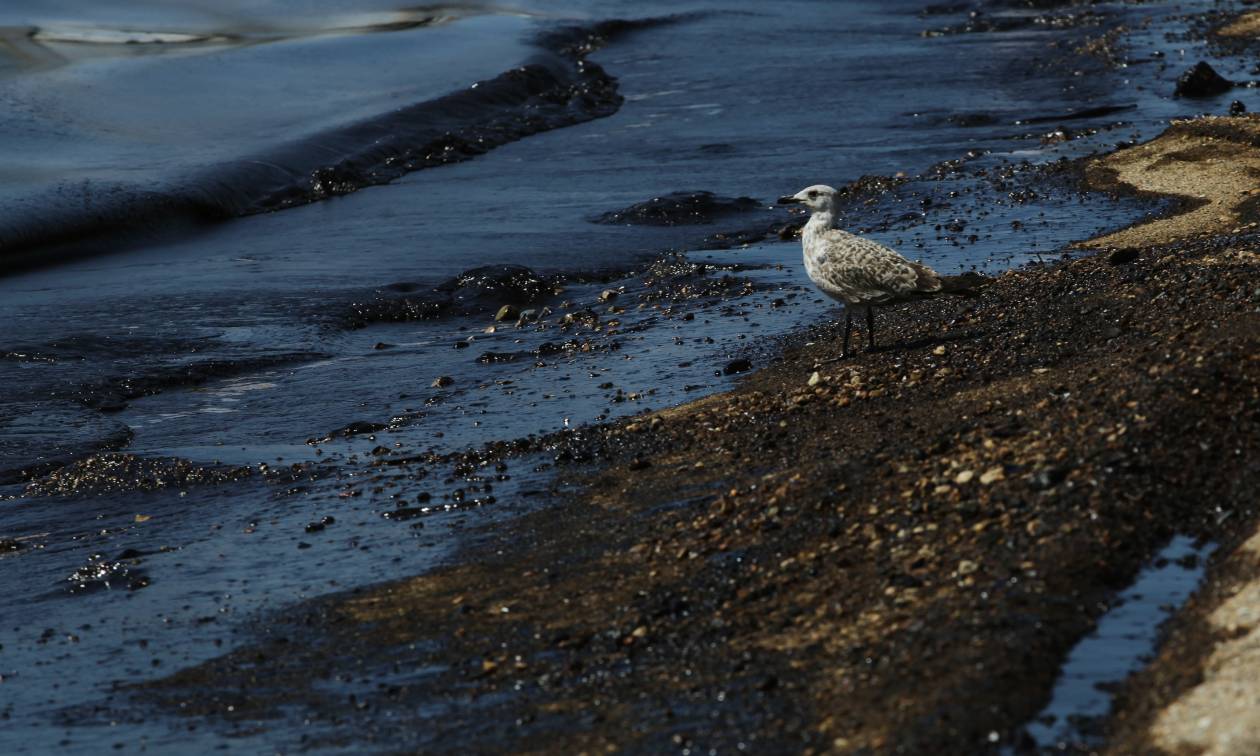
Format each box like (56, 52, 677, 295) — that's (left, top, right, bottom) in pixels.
(0, 15, 688, 275)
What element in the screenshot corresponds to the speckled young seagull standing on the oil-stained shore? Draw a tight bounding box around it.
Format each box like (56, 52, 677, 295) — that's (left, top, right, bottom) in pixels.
(779, 184, 985, 359)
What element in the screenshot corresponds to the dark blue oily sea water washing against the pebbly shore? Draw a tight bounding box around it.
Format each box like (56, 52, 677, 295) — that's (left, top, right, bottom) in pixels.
(0, 0, 1245, 752)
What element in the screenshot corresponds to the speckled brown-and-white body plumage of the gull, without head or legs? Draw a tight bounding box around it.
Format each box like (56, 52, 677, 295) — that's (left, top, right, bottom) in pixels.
(801, 210, 941, 306)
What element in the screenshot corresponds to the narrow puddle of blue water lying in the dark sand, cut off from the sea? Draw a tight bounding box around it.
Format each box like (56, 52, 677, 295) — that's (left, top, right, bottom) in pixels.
(1021, 536, 1215, 752)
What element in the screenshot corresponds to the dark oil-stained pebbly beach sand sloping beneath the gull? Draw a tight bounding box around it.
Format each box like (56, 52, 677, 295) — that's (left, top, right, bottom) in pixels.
(130, 117, 1260, 753)
